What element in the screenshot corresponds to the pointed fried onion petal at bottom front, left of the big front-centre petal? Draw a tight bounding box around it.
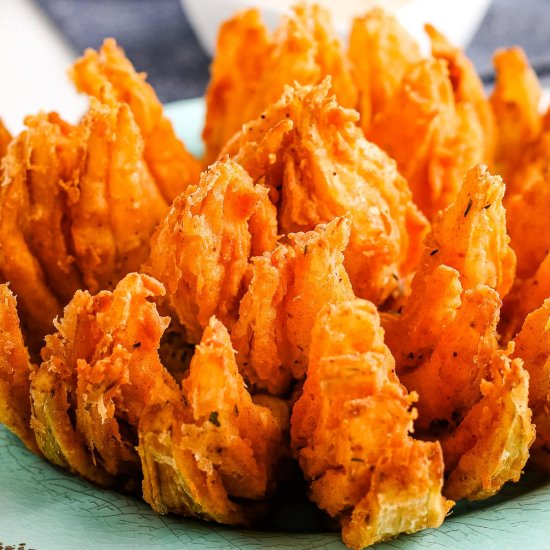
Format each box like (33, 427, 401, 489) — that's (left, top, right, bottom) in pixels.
(138, 318, 288, 525)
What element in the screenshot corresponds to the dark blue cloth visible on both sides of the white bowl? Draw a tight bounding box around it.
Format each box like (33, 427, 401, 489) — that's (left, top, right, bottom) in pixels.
(35, 0, 550, 102)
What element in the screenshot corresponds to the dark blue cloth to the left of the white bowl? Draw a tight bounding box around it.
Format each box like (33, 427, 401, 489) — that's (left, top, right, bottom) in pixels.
(34, 0, 210, 103)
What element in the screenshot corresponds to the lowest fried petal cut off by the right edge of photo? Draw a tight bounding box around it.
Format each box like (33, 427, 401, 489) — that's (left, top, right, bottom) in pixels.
(513, 299, 550, 471)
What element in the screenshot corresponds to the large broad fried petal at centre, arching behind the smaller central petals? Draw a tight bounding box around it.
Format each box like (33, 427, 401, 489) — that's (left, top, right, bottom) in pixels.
(226, 81, 427, 303)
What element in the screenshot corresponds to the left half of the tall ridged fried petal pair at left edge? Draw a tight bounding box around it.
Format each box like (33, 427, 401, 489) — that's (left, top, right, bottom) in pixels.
(0, 113, 82, 352)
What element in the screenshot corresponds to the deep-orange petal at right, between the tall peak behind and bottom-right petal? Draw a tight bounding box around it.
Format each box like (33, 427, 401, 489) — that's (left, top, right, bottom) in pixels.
(398, 276, 501, 430)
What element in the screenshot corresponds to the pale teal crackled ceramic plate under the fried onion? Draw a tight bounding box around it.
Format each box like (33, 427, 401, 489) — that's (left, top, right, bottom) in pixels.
(0, 100, 550, 550)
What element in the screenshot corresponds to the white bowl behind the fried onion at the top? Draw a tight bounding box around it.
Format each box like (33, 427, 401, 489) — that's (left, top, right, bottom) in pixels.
(181, 0, 491, 55)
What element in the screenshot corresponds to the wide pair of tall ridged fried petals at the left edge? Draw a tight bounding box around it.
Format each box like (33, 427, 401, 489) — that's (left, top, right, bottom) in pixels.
(0, 96, 168, 352)
